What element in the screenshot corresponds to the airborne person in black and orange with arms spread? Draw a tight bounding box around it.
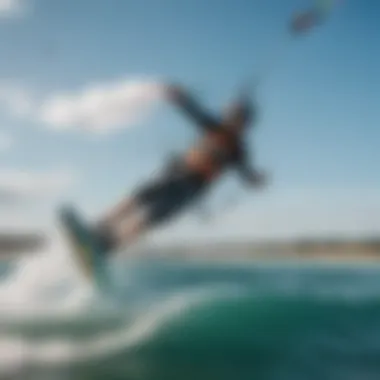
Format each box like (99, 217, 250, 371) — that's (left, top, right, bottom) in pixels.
(95, 85, 266, 252)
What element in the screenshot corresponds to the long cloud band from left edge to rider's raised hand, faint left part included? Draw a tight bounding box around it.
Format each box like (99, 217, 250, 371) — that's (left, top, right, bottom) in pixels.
(0, 77, 163, 133)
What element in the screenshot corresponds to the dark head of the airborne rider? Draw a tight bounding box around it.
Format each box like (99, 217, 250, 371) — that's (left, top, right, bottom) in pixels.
(223, 93, 256, 131)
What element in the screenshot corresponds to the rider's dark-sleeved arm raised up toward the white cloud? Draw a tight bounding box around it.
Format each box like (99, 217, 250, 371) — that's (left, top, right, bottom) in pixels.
(166, 85, 219, 130)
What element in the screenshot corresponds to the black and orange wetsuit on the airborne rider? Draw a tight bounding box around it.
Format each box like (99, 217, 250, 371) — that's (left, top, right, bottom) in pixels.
(135, 89, 255, 224)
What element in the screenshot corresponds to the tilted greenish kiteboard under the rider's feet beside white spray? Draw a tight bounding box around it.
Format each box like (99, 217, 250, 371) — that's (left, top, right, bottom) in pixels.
(59, 207, 110, 292)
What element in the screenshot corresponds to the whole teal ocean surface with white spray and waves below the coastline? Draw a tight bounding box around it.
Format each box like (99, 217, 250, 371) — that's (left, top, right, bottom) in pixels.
(0, 238, 380, 380)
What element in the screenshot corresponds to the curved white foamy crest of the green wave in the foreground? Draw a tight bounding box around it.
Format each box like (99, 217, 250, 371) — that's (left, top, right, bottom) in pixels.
(0, 284, 232, 373)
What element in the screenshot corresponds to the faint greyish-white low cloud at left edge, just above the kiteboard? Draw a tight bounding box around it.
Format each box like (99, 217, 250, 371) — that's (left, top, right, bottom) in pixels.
(0, 169, 75, 201)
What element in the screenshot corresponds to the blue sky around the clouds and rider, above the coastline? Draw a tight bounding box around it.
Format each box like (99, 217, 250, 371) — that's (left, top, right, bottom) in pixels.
(0, 0, 380, 239)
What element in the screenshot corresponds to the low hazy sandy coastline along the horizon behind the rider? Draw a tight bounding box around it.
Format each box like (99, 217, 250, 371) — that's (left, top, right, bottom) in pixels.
(0, 233, 380, 261)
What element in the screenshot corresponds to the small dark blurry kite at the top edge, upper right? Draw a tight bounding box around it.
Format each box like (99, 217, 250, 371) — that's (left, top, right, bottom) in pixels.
(290, 0, 335, 35)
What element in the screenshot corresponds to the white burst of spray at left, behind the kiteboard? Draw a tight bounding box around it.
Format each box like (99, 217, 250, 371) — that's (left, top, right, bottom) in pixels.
(0, 226, 94, 318)
